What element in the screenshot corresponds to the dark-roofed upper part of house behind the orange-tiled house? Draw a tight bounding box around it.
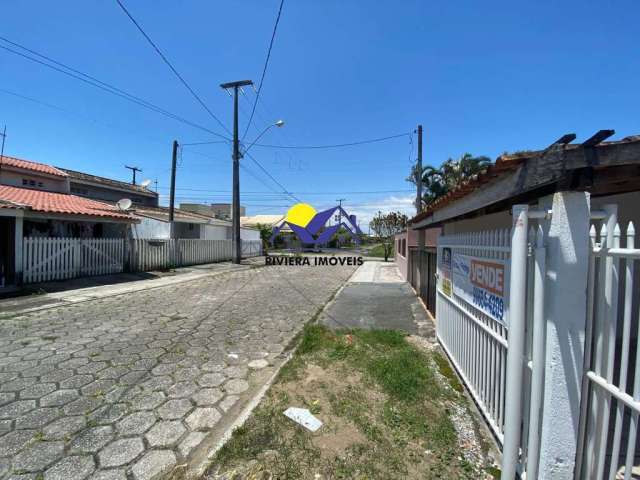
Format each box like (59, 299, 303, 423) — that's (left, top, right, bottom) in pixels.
(57, 167, 158, 207)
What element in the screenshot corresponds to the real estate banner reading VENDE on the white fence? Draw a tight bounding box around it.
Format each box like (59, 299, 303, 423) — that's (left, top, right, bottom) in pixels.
(452, 253, 508, 324)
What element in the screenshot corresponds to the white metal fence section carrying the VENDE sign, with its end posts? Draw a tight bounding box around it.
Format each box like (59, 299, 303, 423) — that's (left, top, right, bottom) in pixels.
(436, 206, 546, 478)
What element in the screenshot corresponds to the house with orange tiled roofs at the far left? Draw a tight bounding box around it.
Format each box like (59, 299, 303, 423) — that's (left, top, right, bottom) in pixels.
(0, 155, 137, 288)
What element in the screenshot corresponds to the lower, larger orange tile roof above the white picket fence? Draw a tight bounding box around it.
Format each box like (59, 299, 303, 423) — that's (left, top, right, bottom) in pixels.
(0, 185, 134, 220)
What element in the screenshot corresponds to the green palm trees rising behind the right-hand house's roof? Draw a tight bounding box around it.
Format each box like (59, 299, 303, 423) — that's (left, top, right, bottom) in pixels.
(407, 153, 491, 206)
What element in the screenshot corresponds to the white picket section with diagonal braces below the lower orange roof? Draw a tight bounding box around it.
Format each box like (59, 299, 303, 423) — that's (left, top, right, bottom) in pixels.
(22, 237, 125, 283)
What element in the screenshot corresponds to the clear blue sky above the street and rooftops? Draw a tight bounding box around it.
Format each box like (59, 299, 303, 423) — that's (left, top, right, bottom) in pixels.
(0, 0, 640, 225)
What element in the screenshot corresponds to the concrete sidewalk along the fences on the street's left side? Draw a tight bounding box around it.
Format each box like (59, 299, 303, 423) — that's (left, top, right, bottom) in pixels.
(0, 257, 264, 318)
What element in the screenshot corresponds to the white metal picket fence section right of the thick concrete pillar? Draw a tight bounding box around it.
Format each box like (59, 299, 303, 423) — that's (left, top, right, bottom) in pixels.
(575, 206, 640, 480)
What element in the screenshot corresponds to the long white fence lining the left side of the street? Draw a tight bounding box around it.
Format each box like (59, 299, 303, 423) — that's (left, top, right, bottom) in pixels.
(23, 237, 262, 283)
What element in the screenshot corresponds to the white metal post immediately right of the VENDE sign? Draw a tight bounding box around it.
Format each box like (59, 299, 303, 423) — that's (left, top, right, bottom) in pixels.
(501, 205, 529, 480)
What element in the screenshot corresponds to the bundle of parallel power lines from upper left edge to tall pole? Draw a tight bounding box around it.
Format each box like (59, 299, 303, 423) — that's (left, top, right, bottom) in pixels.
(0, 37, 227, 139)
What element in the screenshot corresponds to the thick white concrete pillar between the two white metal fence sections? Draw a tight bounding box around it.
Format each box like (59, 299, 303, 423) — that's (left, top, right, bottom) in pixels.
(538, 192, 591, 480)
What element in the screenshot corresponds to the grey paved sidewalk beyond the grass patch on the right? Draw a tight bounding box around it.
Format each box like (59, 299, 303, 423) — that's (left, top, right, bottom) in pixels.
(320, 261, 434, 337)
